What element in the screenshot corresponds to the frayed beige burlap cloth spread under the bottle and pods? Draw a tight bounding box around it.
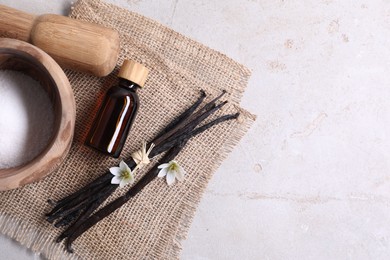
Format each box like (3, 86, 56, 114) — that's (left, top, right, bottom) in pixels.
(0, 0, 255, 259)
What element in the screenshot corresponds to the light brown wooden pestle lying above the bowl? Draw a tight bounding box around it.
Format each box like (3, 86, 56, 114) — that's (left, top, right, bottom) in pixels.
(0, 5, 120, 77)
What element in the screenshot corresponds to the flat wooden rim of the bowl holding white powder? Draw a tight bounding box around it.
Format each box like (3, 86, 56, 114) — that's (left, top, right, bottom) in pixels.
(0, 38, 76, 191)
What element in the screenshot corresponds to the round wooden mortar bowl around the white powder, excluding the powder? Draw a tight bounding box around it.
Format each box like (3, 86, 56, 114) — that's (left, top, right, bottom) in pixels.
(0, 38, 76, 191)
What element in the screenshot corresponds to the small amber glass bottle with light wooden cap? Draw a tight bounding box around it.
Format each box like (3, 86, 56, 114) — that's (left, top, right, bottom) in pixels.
(85, 60, 149, 158)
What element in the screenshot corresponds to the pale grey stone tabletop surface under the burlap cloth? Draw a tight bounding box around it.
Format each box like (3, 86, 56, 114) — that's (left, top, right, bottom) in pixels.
(0, 0, 390, 259)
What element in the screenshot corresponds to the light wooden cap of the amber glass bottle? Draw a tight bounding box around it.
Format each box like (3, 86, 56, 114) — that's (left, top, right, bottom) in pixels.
(118, 60, 149, 87)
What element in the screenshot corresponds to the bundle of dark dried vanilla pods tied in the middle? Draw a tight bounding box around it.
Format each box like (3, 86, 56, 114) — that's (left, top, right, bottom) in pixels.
(46, 90, 239, 252)
